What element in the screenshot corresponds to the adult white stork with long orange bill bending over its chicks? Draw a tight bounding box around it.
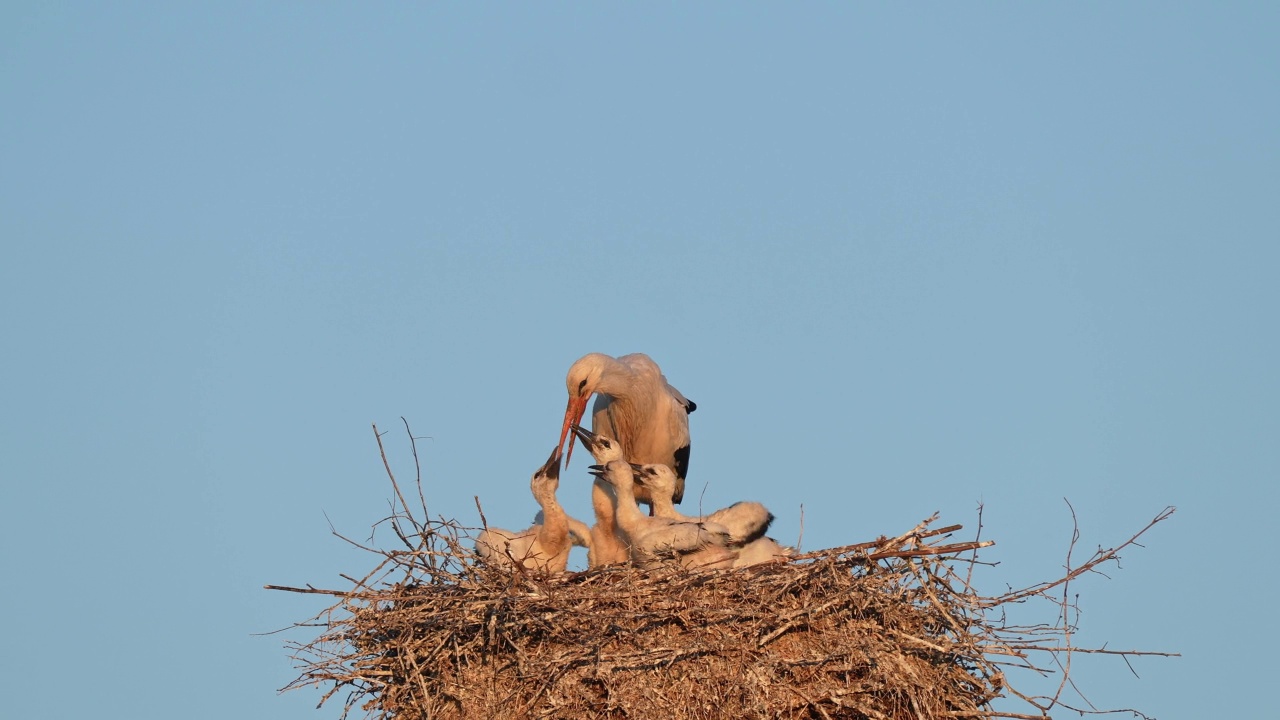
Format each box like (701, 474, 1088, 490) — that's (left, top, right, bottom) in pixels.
(559, 352, 698, 505)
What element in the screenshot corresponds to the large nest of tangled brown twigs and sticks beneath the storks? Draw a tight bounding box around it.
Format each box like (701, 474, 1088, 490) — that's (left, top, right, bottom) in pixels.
(268, 427, 1172, 720)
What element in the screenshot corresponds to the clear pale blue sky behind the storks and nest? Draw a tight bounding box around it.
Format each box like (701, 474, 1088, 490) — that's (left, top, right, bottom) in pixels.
(0, 3, 1280, 720)
